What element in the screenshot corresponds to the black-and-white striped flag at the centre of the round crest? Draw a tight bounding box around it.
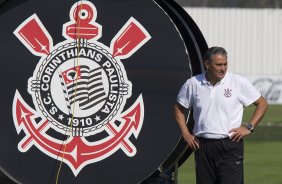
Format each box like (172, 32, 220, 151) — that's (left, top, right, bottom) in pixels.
(59, 65, 107, 110)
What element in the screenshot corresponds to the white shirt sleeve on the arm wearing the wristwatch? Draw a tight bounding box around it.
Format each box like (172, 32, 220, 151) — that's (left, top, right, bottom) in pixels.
(240, 77, 261, 106)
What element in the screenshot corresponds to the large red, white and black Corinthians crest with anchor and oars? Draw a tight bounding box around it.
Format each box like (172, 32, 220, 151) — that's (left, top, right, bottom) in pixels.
(13, 1, 151, 176)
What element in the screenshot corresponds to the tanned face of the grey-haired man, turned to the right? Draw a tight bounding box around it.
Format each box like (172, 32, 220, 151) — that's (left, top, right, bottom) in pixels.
(205, 54, 227, 82)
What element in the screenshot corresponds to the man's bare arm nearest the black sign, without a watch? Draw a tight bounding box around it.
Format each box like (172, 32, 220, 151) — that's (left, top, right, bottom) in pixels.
(174, 103, 199, 150)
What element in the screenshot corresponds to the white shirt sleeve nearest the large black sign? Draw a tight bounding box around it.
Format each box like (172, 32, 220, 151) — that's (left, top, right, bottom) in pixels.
(177, 79, 192, 109)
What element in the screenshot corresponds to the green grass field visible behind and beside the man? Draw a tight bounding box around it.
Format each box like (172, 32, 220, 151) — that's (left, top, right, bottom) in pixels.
(178, 105, 282, 184)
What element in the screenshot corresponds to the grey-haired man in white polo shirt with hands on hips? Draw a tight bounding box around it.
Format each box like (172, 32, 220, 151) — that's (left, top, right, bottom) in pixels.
(174, 47, 268, 184)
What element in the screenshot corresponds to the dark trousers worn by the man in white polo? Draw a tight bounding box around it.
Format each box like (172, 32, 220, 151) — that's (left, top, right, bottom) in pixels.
(195, 138, 244, 184)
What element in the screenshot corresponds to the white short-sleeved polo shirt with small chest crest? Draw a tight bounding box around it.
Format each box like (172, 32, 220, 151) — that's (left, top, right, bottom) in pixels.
(177, 73, 261, 139)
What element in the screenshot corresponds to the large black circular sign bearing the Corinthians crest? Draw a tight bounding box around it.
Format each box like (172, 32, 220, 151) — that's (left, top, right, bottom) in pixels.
(0, 0, 206, 184)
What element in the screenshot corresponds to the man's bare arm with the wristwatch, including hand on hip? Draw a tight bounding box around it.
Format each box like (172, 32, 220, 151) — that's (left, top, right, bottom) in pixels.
(229, 96, 268, 141)
